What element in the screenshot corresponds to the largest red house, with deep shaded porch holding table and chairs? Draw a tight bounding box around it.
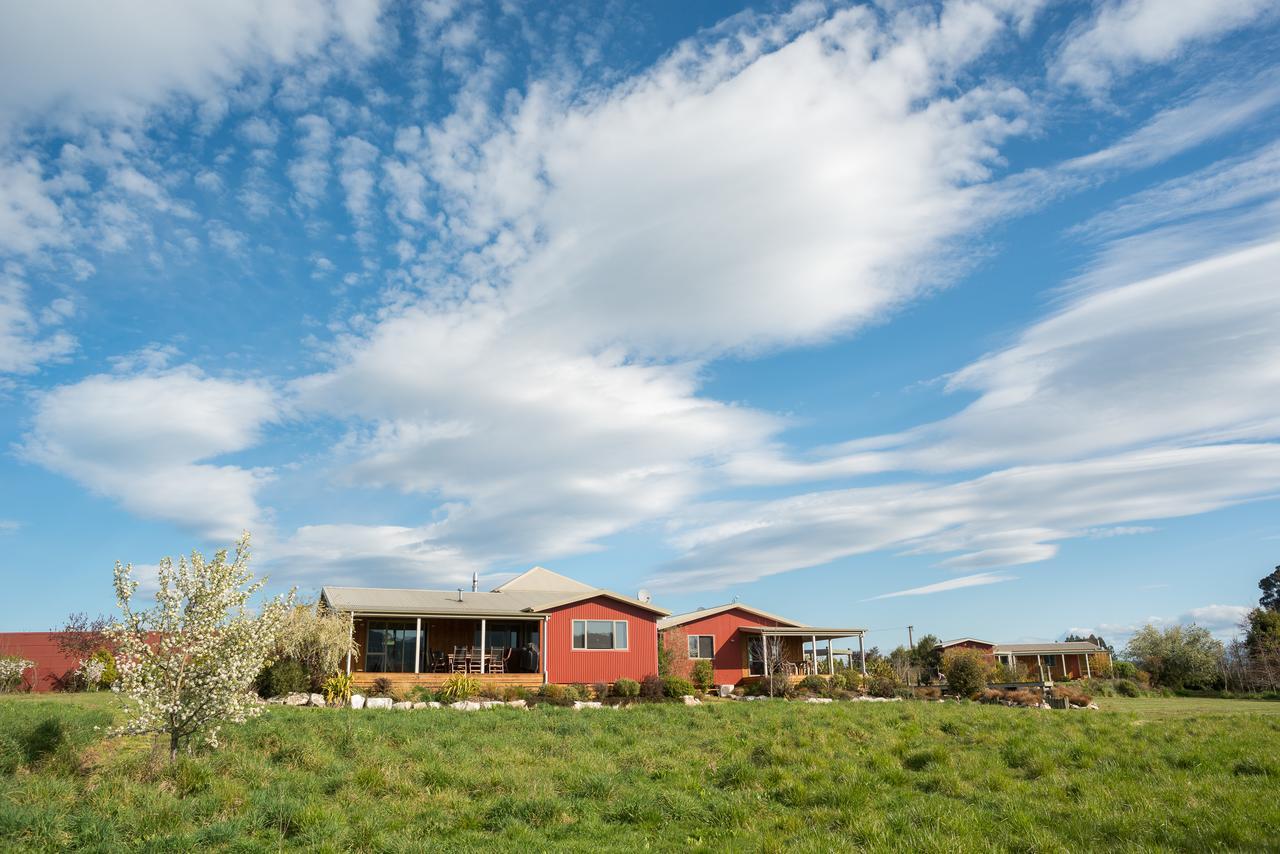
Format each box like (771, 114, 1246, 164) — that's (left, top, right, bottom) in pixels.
(320, 566, 668, 686)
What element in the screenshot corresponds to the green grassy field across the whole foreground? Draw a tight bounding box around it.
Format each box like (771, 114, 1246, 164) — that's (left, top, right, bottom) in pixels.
(0, 698, 1280, 851)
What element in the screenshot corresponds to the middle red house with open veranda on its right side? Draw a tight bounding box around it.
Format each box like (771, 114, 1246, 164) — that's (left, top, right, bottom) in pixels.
(658, 602, 865, 685)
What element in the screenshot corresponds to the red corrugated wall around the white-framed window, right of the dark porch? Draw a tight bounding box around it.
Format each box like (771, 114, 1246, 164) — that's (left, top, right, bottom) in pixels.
(547, 597, 658, 684)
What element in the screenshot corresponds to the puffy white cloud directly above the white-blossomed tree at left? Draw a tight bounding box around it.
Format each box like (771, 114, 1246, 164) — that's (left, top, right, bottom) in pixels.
(20, 367, 280, 540)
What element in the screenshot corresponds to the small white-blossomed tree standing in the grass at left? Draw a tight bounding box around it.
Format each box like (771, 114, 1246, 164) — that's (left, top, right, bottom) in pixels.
(110, 533, 293, 759)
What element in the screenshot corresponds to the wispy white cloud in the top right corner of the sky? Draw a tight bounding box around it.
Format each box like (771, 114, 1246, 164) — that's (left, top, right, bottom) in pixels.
(1051, 0, 1275, 92)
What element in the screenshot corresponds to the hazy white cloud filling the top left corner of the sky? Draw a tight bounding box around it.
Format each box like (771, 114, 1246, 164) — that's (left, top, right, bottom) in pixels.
(0, 0, 380, 123)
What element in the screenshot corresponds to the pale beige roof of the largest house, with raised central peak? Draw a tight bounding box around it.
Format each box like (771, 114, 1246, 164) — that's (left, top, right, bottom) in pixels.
(320, 566, 671, 617)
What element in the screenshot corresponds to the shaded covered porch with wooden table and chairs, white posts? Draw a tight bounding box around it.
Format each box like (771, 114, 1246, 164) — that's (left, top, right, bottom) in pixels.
(347, 612, 547, 685)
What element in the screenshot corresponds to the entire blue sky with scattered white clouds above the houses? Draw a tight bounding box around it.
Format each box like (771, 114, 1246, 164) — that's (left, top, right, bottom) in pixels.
(0, 0, 1280, 648)
